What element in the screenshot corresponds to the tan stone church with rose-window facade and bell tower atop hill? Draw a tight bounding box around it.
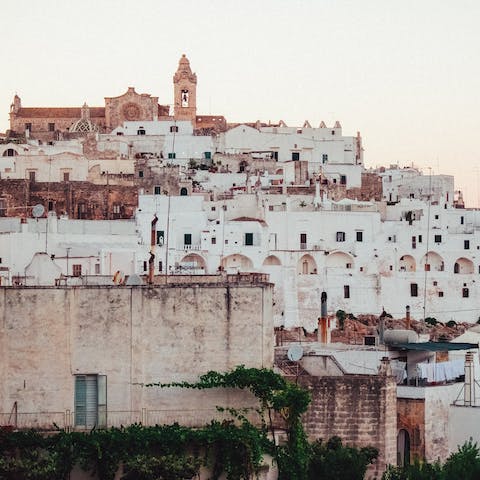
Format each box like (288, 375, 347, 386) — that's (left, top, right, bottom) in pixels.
(10, 55, 227, 142)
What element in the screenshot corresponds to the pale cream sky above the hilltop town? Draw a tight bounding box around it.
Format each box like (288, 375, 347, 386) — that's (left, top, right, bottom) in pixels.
(0, 0, 480, 207)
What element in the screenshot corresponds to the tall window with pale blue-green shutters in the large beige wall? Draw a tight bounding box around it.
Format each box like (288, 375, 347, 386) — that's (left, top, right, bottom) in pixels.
(75, 375, 107, 428)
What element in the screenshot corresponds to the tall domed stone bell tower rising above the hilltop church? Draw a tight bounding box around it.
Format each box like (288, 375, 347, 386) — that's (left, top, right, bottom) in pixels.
(173, 54, 197, 128)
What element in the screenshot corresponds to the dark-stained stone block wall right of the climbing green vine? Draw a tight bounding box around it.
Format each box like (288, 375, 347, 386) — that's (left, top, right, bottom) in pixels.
(299, 375, 397, 478)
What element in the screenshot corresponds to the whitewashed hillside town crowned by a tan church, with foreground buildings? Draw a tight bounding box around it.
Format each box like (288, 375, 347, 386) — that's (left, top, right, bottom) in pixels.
(0, 55, 480, 479)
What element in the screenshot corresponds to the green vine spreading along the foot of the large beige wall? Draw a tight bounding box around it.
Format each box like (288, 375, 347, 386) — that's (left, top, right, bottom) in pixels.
(0, 366, 373, 480)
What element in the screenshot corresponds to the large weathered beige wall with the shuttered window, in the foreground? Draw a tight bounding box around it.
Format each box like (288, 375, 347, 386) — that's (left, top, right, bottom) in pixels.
(0, 283, 273, 422)
